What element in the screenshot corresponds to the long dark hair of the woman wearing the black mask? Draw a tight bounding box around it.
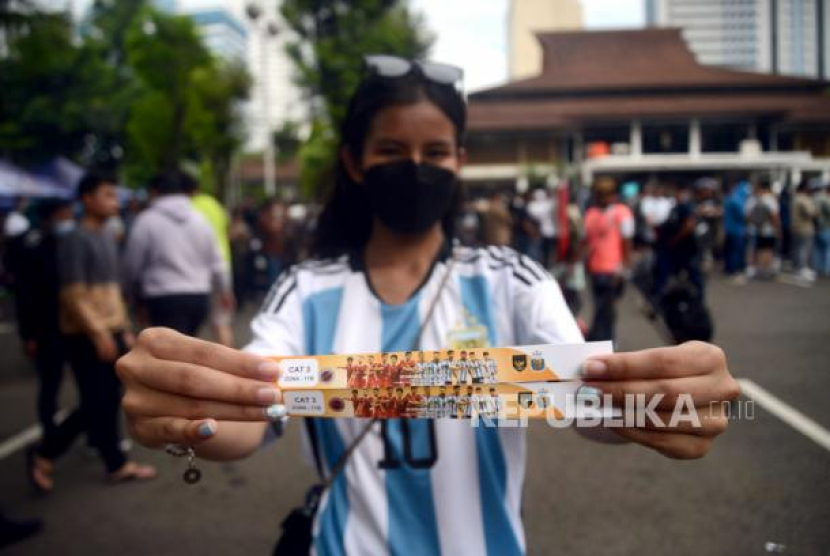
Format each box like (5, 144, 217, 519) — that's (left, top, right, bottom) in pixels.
(313, 68, 467, 257)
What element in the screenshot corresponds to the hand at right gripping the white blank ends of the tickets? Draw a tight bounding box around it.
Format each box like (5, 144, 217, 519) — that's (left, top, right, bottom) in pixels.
(582, 342, 741, 459)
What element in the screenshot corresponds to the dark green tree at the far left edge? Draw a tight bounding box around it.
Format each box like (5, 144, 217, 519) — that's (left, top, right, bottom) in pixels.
(0, 0, 143, 166)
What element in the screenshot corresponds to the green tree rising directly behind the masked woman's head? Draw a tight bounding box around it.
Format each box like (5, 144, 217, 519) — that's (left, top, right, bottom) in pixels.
(281, 0, 432, 194)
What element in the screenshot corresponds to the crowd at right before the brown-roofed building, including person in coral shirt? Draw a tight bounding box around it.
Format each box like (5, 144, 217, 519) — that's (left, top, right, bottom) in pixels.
(460, 175, 830, 346)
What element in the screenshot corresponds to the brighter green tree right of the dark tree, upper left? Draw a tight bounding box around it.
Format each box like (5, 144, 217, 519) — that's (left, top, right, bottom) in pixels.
(121, 9, 251, 191)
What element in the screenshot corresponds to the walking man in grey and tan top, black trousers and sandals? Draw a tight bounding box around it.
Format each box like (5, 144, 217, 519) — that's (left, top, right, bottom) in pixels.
(32, 173, 156, 490)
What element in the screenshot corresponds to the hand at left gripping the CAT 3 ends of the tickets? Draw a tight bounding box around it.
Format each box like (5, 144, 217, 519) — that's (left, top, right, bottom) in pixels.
(116, 328, 282, 448)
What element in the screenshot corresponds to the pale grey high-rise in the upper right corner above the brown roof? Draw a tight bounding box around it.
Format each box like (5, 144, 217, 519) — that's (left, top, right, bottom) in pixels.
(646, 0, 830, 79)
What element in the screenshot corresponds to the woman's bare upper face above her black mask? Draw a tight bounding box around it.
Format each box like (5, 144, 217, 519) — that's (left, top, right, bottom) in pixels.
(344, 101, 466, 183)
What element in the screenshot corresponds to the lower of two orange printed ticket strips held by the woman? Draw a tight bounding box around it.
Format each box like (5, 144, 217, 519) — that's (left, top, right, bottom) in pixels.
(283, 381, 618, 420)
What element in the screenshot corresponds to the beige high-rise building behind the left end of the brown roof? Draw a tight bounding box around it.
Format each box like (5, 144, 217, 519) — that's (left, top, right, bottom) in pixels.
(508, 0, 582, 79)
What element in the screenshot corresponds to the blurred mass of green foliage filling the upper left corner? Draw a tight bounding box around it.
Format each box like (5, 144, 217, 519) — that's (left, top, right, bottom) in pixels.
(0, 0, 250, 194)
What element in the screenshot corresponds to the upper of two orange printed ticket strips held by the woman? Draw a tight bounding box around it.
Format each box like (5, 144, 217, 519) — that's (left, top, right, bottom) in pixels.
(271, 342, 613, 390)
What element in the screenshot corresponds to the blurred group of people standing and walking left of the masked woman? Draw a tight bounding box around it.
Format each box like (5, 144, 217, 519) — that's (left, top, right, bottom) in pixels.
(2, 171, 324, 516)
